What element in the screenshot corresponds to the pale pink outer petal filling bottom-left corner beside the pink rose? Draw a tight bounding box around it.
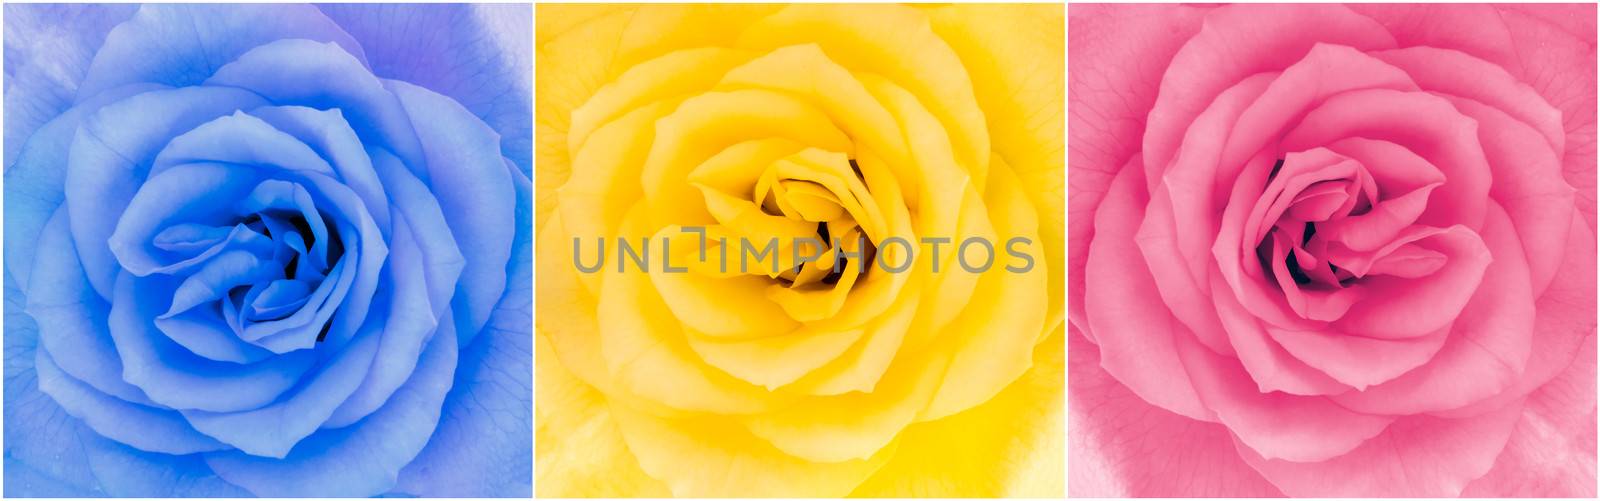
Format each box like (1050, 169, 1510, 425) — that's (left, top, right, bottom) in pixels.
(1067, 327, 1282, 498)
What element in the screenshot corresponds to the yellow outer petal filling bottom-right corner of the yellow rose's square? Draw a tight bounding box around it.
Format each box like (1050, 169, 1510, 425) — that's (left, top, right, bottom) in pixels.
(850, 328, 1066, 499)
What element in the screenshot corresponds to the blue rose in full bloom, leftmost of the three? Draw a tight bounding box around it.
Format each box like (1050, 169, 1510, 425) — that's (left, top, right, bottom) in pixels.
(5, 5, 533, 496)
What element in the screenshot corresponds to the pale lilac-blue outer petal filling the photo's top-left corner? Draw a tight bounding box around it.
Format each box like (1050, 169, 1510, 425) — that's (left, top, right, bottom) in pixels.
(5, 3, 138, 168)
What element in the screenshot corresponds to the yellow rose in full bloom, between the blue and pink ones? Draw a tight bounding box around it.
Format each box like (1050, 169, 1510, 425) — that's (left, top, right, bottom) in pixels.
(536, 5, 1066, 498)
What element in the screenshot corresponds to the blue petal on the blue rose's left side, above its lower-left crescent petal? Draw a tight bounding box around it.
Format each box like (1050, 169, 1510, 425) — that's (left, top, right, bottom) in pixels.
(26, 210, 154, 405)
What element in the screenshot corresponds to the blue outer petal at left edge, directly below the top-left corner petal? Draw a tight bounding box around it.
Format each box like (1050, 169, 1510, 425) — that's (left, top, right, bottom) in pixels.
(3, 82, 155, 288)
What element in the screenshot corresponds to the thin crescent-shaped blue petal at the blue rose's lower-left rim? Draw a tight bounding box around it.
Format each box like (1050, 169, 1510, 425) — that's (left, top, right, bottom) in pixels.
(34, 345, 227, 455)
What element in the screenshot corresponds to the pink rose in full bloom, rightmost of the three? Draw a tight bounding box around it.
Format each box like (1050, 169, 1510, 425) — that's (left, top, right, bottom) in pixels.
(1067, 5, 1595, 498)
